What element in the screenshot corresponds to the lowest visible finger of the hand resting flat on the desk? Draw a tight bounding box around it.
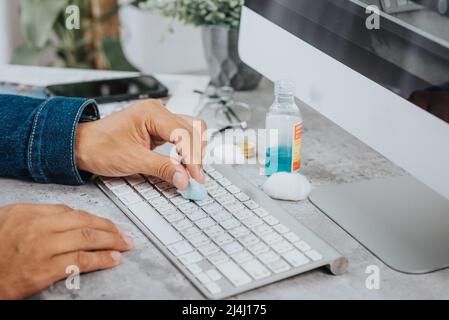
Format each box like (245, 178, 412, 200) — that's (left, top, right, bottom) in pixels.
(52, 251, 122, 282)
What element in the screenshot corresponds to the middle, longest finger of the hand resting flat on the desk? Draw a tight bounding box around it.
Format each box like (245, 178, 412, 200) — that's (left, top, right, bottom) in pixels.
(45, 228, 133, 256)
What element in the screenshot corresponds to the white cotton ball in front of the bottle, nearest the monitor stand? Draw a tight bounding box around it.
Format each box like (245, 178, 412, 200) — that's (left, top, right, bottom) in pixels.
(263, 172, 312, 201)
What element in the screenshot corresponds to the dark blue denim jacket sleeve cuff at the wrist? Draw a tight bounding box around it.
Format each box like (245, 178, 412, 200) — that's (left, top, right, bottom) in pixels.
(0, 95, 99, 185)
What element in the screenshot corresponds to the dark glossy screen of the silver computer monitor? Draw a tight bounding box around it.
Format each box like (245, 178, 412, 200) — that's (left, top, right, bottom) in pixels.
(245, 0, 449, 123)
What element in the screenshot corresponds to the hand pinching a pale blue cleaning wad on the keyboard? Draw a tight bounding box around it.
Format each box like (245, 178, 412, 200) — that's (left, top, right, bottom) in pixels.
(75, 100, 206, 190)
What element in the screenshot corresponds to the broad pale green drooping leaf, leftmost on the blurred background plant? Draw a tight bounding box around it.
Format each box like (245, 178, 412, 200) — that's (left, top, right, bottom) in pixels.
(21, 0, 69, 48)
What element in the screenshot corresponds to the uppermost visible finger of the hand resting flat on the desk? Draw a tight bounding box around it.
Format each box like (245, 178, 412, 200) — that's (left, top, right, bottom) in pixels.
(42, 210, 122, 233)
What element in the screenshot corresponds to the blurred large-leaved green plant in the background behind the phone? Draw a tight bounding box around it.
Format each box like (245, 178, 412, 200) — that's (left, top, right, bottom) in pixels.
(11, 0, 136, 71)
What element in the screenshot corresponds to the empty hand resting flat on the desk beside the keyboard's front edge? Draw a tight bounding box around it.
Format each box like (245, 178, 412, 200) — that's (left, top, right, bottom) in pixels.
(0, 204, 133, 299)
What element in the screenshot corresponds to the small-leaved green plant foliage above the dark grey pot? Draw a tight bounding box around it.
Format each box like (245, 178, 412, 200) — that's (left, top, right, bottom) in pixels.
(136, 0, 244, 29)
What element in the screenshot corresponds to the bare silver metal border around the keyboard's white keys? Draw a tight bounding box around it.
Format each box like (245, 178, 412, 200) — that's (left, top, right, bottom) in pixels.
(95, 165, 348, 299)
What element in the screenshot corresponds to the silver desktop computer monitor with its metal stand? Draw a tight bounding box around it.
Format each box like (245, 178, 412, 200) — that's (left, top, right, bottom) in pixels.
(239, 0, 449, 273)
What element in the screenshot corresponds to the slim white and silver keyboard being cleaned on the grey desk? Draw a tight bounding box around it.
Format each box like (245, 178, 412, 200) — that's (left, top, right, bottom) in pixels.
(97, 166, 347, 299)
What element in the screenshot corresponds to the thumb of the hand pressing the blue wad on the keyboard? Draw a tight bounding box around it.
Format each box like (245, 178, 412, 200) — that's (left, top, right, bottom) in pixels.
(142, 150, 189, 190)
